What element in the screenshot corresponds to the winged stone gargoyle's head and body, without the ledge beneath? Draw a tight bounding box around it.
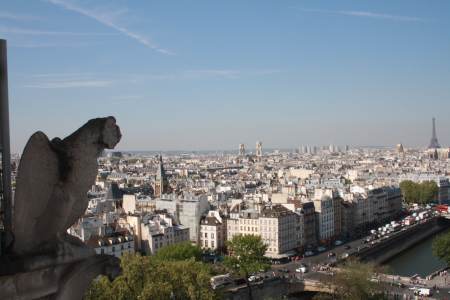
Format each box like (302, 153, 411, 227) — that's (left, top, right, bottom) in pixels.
(12, 117, 121, 255)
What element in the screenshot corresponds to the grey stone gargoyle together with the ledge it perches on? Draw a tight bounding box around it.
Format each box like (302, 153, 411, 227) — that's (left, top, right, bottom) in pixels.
(0, 117, 121, 299)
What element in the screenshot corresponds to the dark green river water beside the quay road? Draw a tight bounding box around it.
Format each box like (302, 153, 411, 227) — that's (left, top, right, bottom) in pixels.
(385, 229, 450, 277)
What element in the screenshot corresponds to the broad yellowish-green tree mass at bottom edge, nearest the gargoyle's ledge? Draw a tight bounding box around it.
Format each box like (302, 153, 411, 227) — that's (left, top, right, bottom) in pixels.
(85, 255, 216, 300)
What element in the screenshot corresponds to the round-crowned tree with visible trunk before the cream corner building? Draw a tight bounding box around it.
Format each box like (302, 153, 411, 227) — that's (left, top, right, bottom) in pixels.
(224, 235, 270, 299)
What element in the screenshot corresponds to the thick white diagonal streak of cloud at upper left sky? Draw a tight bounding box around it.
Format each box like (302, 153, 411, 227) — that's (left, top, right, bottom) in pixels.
(47, 0, 174, 55)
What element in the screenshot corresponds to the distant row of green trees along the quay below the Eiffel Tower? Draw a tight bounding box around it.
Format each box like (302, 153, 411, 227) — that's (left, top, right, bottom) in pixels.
(400, 180, 439, 204)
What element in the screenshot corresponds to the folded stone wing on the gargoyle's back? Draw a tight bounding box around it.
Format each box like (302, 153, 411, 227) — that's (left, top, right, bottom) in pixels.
(13, 131, 59, 253)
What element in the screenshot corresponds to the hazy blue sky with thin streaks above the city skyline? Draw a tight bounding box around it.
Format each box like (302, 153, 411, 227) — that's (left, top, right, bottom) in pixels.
(0, 0, 450, 152)
